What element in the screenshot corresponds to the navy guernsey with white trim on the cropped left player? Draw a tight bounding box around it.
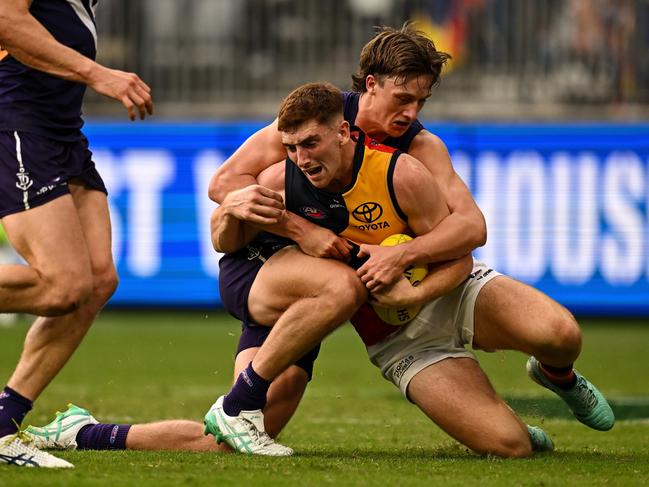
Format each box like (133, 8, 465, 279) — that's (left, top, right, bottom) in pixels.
(0, 0, 98, 141)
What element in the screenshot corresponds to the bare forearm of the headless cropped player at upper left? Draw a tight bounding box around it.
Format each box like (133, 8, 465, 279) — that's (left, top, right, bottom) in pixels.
(0, 9, 101, 84)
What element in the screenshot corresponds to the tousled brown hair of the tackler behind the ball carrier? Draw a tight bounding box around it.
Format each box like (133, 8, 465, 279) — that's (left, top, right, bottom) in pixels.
(352, 22, 451, 92)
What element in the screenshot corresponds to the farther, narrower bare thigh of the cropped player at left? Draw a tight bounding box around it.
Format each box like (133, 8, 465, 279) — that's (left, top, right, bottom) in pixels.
(70, 181, 116, 280)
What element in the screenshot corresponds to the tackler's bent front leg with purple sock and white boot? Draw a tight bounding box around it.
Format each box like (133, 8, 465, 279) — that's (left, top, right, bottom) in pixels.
(205, 247, 367, 456)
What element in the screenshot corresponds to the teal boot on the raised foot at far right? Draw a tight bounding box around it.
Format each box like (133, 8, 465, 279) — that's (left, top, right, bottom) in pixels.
(527, 357, 615, 431)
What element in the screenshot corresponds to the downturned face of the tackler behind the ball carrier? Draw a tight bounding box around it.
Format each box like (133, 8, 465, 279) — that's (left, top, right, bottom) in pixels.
(368, 75, 432, 137)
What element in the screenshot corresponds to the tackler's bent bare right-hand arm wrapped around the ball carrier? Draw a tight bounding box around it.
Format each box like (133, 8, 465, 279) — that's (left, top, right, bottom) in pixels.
(404, 130, 487, 265)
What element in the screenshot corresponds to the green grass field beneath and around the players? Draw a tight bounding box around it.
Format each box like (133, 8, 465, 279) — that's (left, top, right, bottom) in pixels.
(0, 311, 649, 487)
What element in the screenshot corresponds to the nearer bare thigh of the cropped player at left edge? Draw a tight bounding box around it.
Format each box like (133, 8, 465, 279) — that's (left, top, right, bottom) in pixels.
(2, 194, 91, 280)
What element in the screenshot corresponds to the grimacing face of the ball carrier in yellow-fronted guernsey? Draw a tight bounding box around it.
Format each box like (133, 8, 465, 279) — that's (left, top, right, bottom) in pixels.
(281, 120, 351, 191)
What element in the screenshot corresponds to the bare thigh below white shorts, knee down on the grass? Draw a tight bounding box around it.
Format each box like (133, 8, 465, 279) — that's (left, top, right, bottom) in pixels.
(408, 358, 530, 456)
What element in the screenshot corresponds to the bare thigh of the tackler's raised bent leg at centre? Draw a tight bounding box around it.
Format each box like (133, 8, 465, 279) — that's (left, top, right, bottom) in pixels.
(248, 246, 364, 325)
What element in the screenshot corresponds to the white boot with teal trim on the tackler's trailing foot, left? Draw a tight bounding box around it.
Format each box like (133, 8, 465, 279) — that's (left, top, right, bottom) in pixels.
(25, 404, 99, 450)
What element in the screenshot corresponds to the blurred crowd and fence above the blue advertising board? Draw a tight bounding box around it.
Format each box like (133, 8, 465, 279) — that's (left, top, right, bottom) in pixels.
(68, 0, 649, 120)
